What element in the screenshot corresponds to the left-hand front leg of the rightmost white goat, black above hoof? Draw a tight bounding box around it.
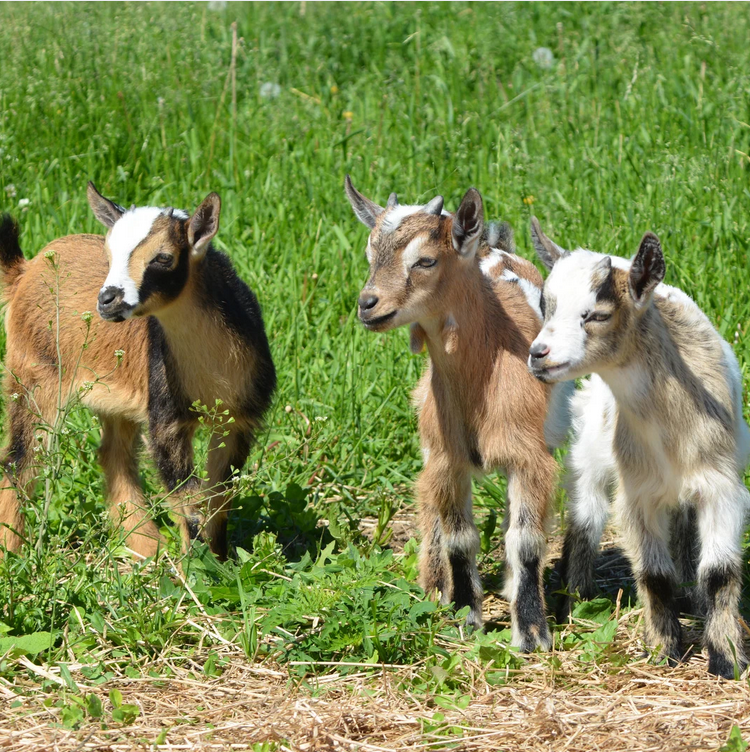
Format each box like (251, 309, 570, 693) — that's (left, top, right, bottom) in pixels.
(616, 483, 682, 666)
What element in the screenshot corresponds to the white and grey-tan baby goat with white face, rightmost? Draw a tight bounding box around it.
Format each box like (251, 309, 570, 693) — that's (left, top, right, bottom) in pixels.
(529, 219, 750, 678)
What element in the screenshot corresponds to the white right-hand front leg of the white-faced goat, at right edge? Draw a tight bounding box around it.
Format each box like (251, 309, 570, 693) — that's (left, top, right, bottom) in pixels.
(697, 478, 750, 679)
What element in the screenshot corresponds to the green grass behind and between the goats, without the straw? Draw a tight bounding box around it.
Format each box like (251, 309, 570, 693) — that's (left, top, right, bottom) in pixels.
(0, 3, 750, 736)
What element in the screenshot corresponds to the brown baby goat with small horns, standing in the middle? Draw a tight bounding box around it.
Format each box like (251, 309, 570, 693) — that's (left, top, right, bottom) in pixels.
(346, 176, 564, 651)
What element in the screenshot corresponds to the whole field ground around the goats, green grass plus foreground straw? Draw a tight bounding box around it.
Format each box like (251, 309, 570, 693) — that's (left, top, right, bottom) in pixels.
(0, 3, 750, 752)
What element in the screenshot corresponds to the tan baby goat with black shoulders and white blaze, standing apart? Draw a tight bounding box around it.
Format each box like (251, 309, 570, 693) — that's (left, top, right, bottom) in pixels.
(0, 183, 276, 557)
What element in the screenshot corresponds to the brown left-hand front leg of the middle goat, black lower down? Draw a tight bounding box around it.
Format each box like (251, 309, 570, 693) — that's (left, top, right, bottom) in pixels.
(417, 457, 482, 628)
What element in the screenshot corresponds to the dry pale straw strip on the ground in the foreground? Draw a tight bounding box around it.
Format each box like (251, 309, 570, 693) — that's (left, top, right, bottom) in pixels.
(5, 514, 750, 752)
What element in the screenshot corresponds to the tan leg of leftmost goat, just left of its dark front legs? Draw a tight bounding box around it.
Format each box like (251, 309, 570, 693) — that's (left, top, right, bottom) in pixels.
(99, 415, 163, 558)
